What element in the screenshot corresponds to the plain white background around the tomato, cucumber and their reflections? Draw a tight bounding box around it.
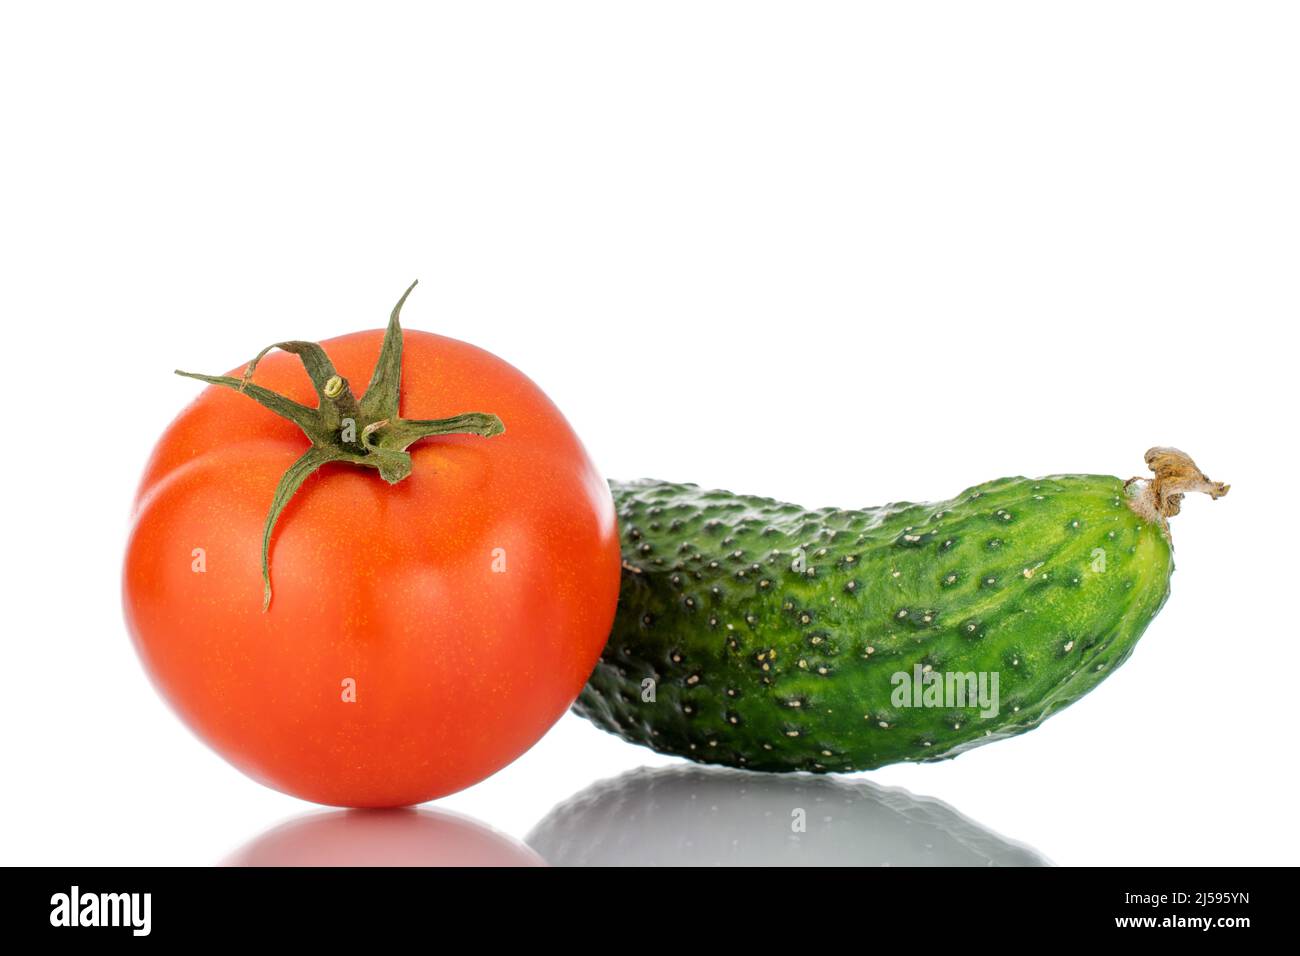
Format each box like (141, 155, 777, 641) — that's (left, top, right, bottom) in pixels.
(0, 0, 1300, 865)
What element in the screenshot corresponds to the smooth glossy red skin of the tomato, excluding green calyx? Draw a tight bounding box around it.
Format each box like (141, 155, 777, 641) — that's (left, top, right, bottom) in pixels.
(124, 332, 620, 806)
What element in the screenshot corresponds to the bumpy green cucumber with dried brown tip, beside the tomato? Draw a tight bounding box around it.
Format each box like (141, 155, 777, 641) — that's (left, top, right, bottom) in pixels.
(573, 449, 1227, 773)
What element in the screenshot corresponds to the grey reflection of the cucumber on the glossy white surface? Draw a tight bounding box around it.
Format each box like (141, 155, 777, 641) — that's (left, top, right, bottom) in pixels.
(528, 766, 1050, 866)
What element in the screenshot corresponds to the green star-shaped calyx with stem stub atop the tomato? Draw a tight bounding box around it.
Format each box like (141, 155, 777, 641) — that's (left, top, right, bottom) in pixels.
(176, 282, 506, 611)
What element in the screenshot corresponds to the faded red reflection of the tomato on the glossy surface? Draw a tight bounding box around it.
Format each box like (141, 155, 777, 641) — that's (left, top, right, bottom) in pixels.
(224, 809, 546, 866)
